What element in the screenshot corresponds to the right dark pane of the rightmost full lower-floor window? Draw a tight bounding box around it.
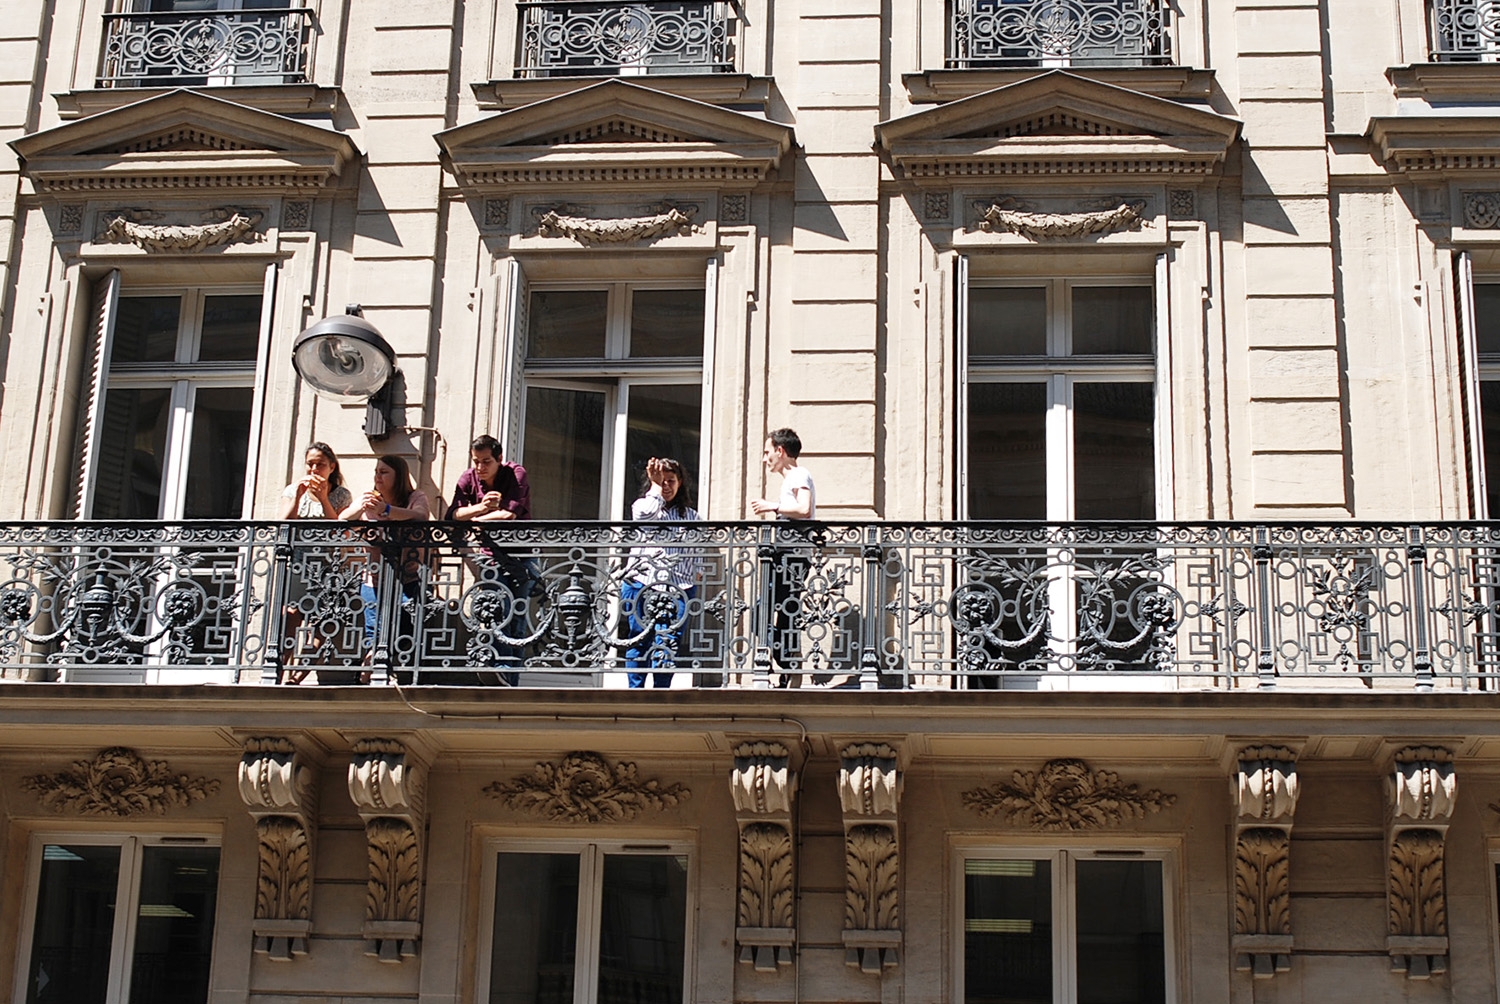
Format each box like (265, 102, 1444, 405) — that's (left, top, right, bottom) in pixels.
(1077, 861, 1167, 1004)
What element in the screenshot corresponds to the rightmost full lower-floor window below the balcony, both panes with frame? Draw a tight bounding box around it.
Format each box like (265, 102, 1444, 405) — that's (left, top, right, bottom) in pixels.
(960, 849, 1173, 1004)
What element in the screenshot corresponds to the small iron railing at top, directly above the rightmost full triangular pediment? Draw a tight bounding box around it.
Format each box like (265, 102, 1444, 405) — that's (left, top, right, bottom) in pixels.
(948, 0, 1172, 69)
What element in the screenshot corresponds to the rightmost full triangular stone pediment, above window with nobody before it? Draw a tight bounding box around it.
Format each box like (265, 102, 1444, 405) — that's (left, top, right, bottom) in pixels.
(876, 71, 1241, 180)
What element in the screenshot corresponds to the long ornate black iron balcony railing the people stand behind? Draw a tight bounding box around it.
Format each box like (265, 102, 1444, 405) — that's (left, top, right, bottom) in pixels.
(0, 521, 1500, 690)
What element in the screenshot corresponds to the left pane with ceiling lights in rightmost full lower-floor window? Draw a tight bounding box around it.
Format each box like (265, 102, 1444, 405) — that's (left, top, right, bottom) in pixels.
(963, 860, 1052, 1004)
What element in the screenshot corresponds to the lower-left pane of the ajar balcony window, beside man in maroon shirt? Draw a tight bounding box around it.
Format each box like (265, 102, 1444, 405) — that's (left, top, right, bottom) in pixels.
(522, 387, 605, 519)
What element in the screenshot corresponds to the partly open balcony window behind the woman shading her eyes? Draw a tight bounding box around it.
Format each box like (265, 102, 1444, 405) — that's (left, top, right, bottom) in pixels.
(522, 282, 704, 519)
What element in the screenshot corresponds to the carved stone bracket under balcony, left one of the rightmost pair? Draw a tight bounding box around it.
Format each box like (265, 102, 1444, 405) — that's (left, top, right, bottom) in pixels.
(1233, 746, 1301, 980)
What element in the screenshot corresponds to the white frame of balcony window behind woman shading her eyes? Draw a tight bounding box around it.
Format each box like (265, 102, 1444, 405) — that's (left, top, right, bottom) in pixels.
(509, 280, 717, 519)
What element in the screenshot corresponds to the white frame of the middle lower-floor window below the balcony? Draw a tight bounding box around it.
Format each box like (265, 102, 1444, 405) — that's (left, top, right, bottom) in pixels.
(474, 836, 698, 1004)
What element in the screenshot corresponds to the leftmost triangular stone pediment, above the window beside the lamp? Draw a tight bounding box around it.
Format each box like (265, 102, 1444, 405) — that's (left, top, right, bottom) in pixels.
(11, 90, 359, 191)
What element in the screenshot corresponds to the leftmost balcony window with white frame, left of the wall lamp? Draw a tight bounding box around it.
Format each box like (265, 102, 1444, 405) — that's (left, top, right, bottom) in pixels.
(87, 288, 263, 519)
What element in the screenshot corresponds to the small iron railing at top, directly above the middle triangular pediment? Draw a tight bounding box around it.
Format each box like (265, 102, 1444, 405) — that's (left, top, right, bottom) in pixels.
(516, 0, 738, 77)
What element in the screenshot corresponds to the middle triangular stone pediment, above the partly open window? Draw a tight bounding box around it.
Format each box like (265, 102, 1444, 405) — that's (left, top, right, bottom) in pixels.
(435, 80, 792, 191)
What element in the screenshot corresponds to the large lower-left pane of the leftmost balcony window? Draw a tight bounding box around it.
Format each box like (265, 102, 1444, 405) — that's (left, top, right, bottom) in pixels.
(90, 387, 173, 519)
